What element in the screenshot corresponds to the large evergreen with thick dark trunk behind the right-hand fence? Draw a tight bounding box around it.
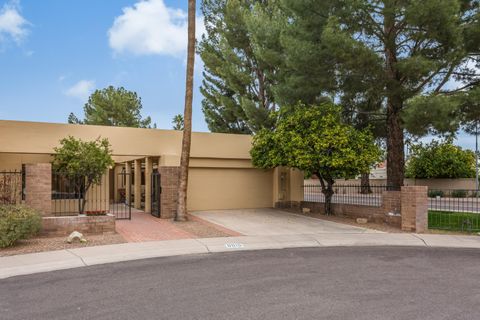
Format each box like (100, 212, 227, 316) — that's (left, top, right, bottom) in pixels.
(322, 0, 479, 186)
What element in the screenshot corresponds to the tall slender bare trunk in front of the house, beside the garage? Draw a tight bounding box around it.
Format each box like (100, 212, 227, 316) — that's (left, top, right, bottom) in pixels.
(175, 0, 196, 221)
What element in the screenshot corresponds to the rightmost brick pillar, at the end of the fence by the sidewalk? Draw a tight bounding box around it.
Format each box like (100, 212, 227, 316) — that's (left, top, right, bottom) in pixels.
(402, 186, 428, 233)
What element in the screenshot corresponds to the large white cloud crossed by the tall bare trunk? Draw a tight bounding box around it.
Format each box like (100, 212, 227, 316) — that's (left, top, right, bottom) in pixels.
(108, 0, 205, 56)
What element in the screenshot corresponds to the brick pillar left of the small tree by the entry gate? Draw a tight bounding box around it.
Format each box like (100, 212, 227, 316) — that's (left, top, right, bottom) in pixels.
(25, 163, 52, 216)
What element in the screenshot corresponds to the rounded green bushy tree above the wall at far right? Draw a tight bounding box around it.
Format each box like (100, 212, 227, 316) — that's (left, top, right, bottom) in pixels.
(406, 139, 475, 179)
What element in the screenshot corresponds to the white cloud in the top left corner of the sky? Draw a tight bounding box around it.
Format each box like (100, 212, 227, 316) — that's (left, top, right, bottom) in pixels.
(0, 1, 30, 43)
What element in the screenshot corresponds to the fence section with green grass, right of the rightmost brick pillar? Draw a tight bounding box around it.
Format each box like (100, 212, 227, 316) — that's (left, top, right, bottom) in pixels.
(428, 189, 480, 232)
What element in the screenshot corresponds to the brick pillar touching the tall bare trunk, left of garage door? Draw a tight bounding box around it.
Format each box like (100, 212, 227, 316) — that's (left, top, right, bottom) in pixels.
(158, 167, 180, 218)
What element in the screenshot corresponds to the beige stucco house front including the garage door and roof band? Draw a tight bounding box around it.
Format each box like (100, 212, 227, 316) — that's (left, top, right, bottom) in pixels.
(0, 120, 303, 210)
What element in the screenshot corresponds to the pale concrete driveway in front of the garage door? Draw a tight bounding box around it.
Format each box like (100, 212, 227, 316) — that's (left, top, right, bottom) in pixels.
(192, 208, 379, 236)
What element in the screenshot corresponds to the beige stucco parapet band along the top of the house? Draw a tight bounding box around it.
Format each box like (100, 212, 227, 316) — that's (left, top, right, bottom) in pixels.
(0, 120, 252, 159)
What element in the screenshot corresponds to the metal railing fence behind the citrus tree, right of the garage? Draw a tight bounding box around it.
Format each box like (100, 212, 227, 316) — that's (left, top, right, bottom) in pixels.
(303, 184, 395, 207)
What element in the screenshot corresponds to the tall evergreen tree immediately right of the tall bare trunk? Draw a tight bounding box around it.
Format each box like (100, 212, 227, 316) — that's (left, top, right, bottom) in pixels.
(198, 0, 277, 133)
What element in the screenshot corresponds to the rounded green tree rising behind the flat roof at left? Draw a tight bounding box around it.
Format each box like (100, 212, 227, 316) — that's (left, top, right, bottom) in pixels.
(68, 86, 156, 128)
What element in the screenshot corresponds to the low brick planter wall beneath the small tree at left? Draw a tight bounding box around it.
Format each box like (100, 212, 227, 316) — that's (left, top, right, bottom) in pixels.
(42, 215, 115, 236)
